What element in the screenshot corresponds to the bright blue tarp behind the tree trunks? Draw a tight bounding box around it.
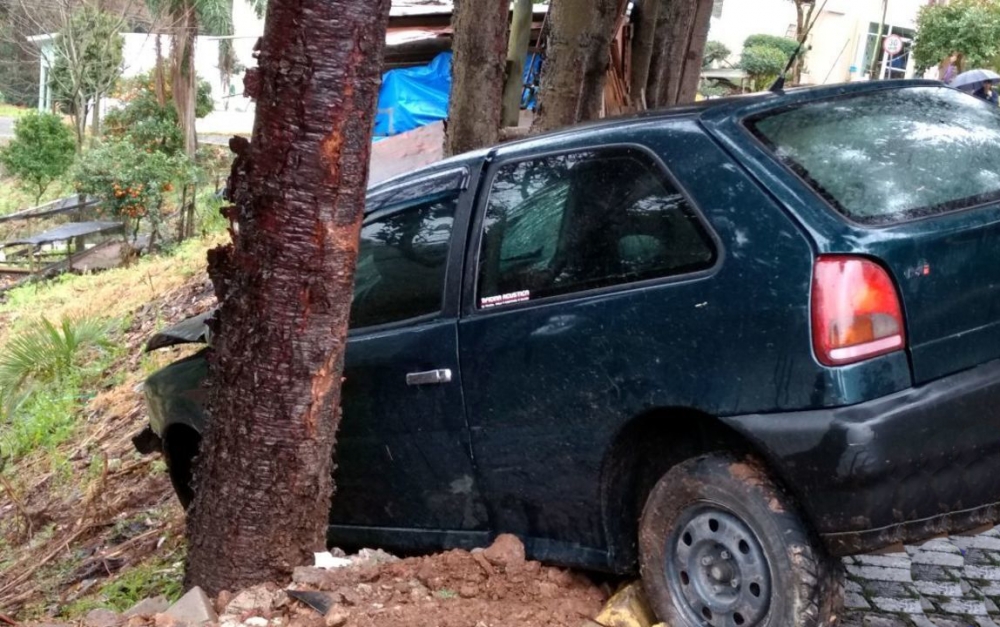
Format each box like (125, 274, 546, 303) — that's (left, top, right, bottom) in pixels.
(375, 52, 542, 141)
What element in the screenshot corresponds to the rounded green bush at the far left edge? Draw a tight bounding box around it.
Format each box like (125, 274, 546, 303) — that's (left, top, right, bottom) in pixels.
(0, 111, 76, 205)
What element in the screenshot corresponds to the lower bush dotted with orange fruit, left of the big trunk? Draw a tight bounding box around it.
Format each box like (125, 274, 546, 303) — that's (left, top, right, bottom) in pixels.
(73, 137, 192, 245)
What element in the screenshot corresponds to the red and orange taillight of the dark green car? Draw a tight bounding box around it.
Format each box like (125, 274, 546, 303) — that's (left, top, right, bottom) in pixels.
(812, 256, 906, 366)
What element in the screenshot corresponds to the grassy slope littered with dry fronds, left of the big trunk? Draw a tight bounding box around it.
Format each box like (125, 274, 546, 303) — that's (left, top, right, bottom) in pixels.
(0, 237, 218, 620)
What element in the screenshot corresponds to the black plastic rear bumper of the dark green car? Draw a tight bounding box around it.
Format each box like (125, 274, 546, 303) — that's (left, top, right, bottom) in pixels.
(723, 361, 1000, 555)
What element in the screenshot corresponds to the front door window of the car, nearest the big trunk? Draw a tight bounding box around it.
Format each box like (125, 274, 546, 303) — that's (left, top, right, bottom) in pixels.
(350, 192, 458, 329)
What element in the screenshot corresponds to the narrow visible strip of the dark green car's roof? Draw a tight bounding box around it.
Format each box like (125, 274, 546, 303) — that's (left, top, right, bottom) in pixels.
(368, 79, 945, 194)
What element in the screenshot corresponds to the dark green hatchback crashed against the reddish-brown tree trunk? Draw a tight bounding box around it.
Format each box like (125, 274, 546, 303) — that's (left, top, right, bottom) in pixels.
(139, 81, 1000, 627)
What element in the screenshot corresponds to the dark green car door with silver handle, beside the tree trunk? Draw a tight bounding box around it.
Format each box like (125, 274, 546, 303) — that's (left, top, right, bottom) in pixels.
(331, 167, 486, 548)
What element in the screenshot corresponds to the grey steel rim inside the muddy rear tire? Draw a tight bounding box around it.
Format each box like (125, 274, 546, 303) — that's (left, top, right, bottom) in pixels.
(665, 503, 771, 627)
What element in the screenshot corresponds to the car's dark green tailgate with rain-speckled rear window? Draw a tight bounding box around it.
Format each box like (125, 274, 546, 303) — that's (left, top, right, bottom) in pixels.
(720, 84, 1000, 383)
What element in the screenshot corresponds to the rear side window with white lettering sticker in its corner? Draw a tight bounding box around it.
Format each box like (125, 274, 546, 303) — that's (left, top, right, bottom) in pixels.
(477, 147, 716, 307)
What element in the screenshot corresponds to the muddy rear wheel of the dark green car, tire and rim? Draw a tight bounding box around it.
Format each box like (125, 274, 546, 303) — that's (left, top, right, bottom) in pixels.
(639, 453, 843, 627)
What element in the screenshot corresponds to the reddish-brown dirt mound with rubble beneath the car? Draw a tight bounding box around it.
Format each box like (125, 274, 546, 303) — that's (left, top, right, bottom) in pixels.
(282, 536, 607, 627)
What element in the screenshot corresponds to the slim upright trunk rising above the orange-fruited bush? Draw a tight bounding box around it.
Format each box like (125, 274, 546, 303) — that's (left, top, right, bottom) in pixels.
(170, 0, 198, 158)
